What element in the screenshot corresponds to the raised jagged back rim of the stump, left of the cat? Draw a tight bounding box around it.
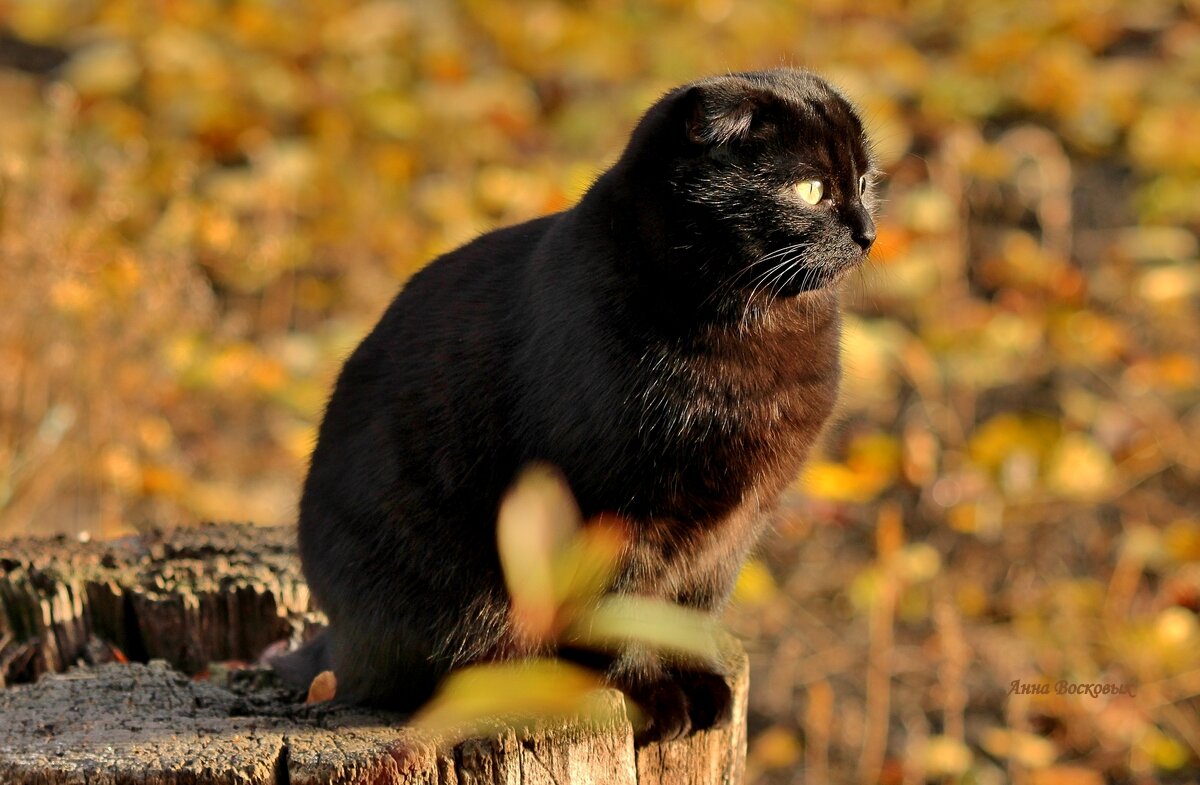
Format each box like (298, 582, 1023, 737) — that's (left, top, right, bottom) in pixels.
(0, 525, 318, 685)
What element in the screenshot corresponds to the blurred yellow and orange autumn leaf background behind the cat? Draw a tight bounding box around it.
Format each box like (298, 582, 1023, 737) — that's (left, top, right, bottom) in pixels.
(0, 0, 1200, 785)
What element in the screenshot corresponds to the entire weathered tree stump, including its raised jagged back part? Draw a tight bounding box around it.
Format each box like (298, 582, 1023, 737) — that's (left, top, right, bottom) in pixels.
(0, 526, 748, 785)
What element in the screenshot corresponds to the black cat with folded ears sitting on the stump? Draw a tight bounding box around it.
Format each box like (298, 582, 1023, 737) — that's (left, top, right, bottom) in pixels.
(280, 68, 875, 736)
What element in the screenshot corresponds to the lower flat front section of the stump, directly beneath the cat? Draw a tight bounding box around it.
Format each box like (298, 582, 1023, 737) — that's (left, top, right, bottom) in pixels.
(0, 655, 748, 785)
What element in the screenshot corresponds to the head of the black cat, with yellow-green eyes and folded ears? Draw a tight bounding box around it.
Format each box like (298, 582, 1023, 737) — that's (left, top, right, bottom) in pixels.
(628, 68, 875, 306)
